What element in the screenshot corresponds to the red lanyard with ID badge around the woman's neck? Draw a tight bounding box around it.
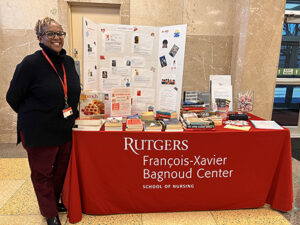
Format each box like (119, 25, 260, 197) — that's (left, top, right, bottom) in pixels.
(42, 50, 73, 119)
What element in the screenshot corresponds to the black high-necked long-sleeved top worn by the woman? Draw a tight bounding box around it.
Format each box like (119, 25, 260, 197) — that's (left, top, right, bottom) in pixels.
(6, 44, 80, 147)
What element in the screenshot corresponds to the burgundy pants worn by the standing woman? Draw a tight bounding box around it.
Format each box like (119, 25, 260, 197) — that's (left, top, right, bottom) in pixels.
(21, 131, 72, 218)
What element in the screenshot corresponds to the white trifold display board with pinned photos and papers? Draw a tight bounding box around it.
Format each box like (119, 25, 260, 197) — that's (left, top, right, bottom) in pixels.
(83, 18, 186, 114)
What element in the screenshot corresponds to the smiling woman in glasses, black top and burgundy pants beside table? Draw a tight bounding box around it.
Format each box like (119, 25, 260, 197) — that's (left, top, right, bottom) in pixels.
(6, 17, 80, 224)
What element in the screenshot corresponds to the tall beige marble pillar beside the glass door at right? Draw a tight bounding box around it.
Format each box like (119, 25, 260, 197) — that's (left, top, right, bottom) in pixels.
(231, 0, 285, 119)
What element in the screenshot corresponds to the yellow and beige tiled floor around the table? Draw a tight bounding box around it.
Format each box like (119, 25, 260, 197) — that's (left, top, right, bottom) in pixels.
(0, 144, 300, 225)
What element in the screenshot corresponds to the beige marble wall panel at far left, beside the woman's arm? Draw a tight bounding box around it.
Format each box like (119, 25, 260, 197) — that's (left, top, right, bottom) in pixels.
(0, 29, 39, 143)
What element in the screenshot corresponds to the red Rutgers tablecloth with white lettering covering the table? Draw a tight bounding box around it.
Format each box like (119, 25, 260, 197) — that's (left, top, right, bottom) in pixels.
(63, 115, 293, 223)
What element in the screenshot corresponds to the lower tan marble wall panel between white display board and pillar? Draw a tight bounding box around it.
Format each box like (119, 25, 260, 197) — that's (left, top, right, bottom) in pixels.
(182, 35, 232, 91)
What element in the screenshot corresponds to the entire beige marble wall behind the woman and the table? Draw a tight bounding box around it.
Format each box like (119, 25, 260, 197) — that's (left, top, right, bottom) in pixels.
(0, 0, 285, 143)
